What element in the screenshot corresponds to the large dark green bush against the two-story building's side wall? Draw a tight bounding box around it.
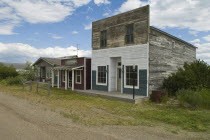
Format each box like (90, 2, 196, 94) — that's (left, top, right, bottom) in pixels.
(163, 60, 210, 96)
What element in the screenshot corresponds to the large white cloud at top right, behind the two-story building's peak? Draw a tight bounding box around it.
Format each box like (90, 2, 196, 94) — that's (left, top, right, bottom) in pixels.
(110, 0, 210, 31)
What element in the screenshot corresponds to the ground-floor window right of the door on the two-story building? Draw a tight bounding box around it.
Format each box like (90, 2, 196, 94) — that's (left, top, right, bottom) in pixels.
(126, 66, 138, 86)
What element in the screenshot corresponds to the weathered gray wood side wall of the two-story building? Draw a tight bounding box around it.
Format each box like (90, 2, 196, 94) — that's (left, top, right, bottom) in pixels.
(149, 28, 196, 93)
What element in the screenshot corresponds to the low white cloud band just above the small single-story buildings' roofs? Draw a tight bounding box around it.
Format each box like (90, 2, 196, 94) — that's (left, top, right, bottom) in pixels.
(0, 42, 91, 63)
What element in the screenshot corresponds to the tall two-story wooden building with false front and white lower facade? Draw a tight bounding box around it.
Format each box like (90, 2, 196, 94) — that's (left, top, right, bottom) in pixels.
(92, 6, 196, 96)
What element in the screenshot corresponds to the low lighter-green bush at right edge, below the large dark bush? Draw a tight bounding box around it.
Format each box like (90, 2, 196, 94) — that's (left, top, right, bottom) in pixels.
(177, 89, 210, 109)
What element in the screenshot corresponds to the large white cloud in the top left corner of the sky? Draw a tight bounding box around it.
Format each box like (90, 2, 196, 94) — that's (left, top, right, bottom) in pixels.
(0, 0, 91, 35)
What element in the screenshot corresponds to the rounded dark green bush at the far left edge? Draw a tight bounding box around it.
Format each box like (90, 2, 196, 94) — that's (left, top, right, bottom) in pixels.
(0, 63, 18, 80)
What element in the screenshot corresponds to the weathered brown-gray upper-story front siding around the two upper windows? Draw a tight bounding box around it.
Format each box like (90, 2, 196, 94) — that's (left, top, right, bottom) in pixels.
(92, 6, 149, 50)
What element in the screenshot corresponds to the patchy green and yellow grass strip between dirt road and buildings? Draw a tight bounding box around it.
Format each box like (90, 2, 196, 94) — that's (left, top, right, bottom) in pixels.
(0, 85, 210, 132)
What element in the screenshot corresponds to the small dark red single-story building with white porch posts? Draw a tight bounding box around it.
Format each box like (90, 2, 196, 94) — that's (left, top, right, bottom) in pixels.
(52, 57, 91, 90)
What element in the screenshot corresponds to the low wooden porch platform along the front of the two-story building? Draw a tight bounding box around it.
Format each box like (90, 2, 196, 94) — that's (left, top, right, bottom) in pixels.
(75, 90, 149, 104)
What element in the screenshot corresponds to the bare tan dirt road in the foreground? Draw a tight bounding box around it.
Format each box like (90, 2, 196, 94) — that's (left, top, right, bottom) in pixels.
(0, 92, 208, 140)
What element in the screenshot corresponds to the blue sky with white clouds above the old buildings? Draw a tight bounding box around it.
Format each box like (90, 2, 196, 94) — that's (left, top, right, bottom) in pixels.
(0, 0, 210, 63)
